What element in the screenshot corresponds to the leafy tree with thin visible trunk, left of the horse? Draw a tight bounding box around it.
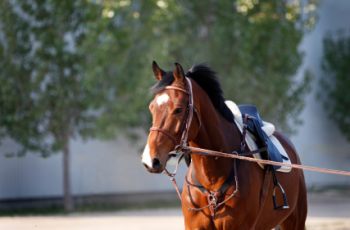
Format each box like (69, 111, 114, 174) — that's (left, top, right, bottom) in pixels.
(0, 0, 103, 211)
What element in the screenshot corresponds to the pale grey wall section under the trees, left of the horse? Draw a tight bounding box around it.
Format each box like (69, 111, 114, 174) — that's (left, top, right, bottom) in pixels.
(0, 138, 185, 199)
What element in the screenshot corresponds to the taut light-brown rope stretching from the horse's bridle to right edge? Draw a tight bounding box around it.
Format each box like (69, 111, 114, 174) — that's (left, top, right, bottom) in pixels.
(185, 146, 350, 176)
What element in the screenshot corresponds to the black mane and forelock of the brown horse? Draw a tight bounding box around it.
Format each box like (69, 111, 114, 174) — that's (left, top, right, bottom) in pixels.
(151, 64, 234, 122)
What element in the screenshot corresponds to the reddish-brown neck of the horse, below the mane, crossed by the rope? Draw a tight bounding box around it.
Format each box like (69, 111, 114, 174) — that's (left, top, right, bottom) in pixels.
(190, 90, 240, 190)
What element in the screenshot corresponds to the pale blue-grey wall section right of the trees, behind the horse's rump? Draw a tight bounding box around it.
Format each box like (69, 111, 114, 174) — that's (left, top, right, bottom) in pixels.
(292, 0, 350, 186)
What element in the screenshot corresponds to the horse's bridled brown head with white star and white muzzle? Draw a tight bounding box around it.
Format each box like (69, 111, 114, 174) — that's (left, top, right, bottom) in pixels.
(142, 62, 197, 173)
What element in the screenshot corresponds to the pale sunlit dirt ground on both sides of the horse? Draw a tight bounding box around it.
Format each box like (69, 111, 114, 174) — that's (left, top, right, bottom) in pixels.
(0, 194, 350, 230)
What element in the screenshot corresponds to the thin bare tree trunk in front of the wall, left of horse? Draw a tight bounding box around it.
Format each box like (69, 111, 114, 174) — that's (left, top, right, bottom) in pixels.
(63, 136, 74, 212)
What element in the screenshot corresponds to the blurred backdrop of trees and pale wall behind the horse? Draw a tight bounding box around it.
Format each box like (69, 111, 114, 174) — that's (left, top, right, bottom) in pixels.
(0, 0, 350, 225)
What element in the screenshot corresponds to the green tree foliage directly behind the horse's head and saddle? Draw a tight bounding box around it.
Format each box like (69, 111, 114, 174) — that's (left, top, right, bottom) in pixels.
(90, 0, 316, 134)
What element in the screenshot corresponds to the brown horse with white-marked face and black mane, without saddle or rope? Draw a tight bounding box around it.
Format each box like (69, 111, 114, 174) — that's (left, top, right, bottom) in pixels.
(142, 62, 307, 230)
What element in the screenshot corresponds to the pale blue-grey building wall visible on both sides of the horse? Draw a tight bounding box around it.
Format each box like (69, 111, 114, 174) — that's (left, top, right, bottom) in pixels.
(0, 0, 350, 199)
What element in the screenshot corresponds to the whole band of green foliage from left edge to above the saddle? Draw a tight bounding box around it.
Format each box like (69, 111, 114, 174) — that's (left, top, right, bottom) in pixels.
(0, 0, 315, 155)
